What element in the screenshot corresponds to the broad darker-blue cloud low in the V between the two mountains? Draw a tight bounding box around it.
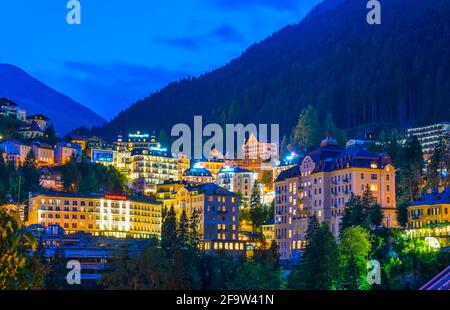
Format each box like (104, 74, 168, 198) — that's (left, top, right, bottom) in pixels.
(60, 61, 188, 119)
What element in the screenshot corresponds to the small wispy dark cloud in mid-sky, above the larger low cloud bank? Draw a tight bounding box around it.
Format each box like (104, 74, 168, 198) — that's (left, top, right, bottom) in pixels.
(154, 24, 246, 50)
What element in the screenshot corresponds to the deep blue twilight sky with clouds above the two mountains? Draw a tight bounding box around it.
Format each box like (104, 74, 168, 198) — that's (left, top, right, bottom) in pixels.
(0, 0, 320, 119)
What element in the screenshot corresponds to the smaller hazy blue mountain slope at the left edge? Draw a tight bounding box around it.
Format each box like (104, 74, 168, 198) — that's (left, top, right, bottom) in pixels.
(0, 64, 105, 134)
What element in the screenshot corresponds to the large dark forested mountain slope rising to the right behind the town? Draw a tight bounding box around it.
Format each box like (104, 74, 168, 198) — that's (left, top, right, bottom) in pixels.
(95, 0, 450, 138)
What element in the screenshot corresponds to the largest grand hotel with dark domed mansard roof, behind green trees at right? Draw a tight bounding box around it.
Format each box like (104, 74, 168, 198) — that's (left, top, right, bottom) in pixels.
(275, 138, 397, 260)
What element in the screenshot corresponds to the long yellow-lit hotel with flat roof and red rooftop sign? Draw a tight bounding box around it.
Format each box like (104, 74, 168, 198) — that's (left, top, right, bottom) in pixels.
(27, 193, 162, 238)
